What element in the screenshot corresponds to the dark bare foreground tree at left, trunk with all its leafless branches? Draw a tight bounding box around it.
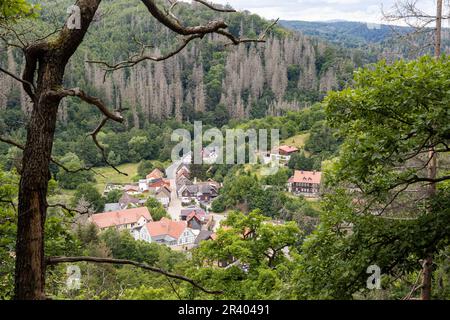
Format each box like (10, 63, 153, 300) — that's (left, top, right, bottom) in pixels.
(0, 0, 275, 299)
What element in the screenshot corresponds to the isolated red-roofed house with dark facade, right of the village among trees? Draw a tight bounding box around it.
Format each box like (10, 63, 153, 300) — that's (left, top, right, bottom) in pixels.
(288, 170, 322, 197)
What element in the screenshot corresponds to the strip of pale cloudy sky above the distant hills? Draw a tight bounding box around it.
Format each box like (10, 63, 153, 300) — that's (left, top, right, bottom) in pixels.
(212, 0, 436, 23)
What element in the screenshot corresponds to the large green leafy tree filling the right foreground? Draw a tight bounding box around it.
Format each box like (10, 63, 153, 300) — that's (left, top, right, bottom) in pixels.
(295, 57, 450, 299)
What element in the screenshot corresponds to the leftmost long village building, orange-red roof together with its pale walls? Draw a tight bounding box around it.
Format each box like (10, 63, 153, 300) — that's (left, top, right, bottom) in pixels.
(88, 207, 153, 230)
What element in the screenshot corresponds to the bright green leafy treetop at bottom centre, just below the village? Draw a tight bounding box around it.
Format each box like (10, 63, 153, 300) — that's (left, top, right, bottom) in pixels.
(191, 211, 300, 299)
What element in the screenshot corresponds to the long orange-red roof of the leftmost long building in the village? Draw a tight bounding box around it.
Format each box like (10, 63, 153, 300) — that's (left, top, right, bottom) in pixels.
(90, 207, 152, 229)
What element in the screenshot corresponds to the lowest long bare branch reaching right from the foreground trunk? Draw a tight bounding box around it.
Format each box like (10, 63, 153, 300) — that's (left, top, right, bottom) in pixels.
(46, 257, 223, 294)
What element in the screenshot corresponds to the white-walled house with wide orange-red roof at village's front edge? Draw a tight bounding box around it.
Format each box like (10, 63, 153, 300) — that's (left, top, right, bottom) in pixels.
(133, 217, 196, 246)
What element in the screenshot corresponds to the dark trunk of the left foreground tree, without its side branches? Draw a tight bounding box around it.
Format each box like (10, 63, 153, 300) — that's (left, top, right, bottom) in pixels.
(14, 0, 101, 300)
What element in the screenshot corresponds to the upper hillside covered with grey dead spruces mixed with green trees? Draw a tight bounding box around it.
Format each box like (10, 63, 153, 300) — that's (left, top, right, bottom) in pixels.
(0, 0, 373, 128)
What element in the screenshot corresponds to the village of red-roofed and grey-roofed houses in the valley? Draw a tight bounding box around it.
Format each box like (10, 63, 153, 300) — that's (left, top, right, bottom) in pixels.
(86, 145, 321, 251)
